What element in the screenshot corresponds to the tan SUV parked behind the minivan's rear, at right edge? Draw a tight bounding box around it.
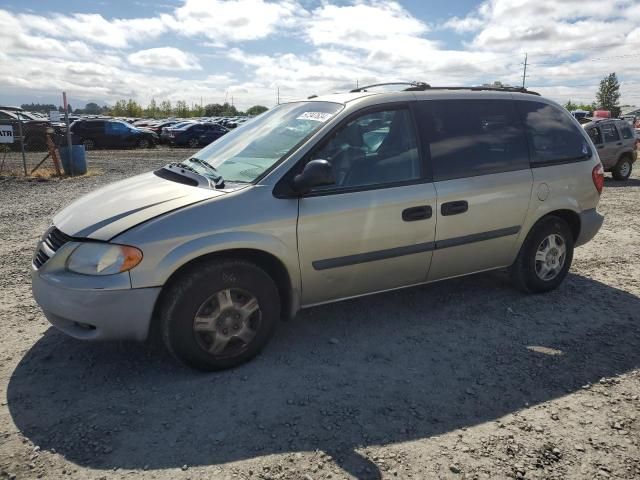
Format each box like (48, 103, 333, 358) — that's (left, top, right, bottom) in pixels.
(583, 118, 636, 180)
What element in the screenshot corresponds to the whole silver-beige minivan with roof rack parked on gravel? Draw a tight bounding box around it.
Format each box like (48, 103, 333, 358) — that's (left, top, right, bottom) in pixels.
(32, 84, 604, 370)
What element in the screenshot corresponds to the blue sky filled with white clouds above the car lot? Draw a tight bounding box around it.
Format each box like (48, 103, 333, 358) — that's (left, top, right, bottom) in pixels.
(0, 0, 640, 108)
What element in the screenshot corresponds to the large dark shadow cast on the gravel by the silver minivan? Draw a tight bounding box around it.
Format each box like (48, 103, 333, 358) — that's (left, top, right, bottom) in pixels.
(7, 273, 640, 478)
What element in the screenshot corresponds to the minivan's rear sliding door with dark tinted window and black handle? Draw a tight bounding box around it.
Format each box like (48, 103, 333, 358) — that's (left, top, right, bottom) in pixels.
(418, 99, 532, 280)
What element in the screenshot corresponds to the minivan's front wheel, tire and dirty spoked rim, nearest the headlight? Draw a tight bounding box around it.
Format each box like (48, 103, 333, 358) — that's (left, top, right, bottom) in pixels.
(160, 260, 280, 371)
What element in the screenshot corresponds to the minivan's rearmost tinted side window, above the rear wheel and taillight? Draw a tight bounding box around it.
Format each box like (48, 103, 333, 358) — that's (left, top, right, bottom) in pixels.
(517, 101, 588, 166)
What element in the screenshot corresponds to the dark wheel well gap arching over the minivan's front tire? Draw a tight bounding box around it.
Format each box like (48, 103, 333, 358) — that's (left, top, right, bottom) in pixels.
(153, 248, 293, 334)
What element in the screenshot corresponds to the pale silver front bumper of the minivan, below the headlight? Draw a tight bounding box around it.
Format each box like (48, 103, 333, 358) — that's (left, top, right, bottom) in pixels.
(31, 269, 160, 341)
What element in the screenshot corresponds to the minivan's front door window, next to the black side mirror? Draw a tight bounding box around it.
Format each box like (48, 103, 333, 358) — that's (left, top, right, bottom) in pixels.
(309, 108, 422, 190)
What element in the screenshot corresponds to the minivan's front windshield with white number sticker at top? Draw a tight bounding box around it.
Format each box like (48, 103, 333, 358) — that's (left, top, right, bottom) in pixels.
(185, 102, 344, 183)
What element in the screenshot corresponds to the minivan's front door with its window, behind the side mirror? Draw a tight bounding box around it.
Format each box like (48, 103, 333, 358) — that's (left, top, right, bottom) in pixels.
(298, 105, 436, 305)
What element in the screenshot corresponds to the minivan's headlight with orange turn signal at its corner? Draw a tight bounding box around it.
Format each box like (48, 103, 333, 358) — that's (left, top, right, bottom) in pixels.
(67, 242, 142, 275)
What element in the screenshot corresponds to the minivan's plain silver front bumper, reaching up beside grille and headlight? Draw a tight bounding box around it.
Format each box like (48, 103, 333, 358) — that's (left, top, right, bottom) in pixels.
(31, 247, 161, 341)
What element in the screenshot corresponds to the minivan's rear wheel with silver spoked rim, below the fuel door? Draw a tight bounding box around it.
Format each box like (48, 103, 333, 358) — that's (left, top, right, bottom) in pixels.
(510, 216, 574, 293)
